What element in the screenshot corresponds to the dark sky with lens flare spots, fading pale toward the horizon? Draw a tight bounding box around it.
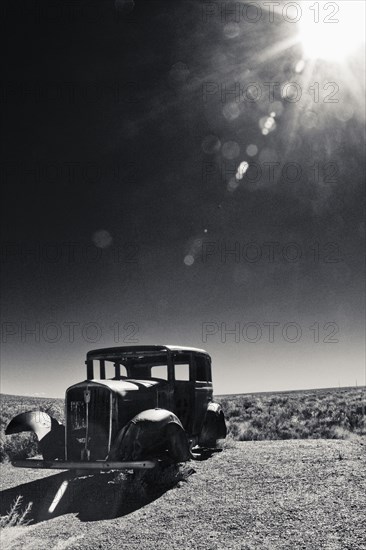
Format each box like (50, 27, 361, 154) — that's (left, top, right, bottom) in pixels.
(1, 0, 365, 395)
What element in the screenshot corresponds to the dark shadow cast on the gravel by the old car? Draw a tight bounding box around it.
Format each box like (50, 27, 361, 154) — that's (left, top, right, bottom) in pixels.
(0, 468, 194, 524)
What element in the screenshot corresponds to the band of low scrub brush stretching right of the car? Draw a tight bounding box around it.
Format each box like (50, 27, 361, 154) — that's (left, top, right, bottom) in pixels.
(222, 388, 366, 441)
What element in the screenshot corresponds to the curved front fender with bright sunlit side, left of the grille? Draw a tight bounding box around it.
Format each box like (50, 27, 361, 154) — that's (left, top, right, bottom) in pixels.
(5, 411, 65, 460)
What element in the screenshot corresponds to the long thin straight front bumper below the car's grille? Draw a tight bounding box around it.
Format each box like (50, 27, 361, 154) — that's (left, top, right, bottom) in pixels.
(12, 458, 157, 470)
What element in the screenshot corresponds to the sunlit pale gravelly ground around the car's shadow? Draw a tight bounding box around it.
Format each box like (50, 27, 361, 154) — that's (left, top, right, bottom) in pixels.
(0, 439, 366, 550)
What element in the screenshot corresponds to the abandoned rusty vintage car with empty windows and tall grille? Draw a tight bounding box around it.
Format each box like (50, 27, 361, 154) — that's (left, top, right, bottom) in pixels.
(5, 345, 226, 470)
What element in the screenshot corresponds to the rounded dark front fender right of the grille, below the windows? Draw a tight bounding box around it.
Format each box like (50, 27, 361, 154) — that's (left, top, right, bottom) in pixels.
(108, 409, 191, 462)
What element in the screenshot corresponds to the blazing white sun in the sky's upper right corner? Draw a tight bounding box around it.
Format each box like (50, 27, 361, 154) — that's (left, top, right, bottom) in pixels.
(299, 0, 365, 62)
